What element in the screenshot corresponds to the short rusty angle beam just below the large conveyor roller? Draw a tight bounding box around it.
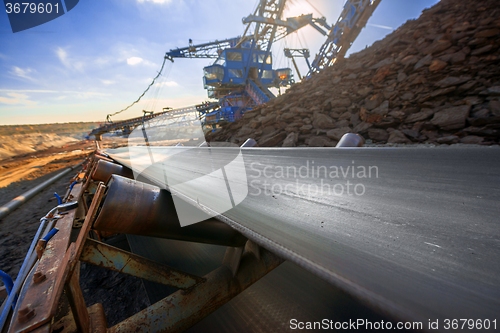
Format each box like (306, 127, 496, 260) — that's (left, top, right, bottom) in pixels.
(80, 238, 204, 289)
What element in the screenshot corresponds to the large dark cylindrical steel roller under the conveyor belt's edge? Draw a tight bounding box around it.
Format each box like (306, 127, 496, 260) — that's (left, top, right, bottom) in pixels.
(93, 175, 247, 247)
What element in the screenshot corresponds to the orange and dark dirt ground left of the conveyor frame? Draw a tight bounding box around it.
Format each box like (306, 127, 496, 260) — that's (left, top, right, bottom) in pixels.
(0, 141, 93, 277)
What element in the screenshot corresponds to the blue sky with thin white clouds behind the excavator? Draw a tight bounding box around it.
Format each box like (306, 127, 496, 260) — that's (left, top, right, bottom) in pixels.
(0, 0, 437, 125)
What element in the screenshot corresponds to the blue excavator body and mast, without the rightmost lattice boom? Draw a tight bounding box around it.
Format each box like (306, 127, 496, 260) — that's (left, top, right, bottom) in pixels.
(165, 0, 329, 127)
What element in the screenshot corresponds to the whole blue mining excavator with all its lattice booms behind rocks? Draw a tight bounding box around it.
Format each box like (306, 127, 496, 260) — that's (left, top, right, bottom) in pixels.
(165, 0, 381, 128)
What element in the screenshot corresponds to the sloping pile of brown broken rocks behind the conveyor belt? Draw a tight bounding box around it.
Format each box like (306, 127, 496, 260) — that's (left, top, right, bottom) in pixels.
(207, 0, 500, 147)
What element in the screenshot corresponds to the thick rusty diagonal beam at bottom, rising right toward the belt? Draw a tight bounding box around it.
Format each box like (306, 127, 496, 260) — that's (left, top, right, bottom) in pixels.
(108, 250, 283, 333)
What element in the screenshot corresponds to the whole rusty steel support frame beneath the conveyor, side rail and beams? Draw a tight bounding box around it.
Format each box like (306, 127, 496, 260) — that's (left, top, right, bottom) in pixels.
(4, 158, 283, 333)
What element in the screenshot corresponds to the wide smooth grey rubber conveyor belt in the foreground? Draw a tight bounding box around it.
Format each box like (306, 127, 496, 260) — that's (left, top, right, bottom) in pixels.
(107, 147, 500, 323)
